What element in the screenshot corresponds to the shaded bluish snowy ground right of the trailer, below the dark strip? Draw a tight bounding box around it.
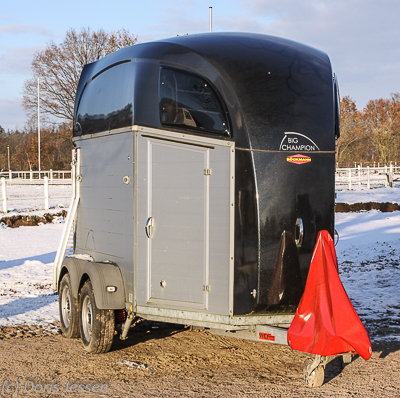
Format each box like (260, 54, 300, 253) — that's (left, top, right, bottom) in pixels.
(336, 210, 400, 341)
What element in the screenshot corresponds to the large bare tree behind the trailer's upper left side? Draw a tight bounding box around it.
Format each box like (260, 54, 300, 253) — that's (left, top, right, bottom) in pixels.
(23, 28, 137, 121)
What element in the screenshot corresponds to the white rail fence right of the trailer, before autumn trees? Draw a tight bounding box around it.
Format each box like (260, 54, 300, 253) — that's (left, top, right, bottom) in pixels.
(335, 164, 400, 191)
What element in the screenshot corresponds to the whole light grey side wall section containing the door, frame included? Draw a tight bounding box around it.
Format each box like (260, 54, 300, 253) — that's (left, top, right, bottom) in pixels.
(136, 127, 234, 315)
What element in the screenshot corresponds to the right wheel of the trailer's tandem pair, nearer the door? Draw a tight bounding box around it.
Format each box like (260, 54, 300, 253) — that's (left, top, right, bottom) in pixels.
(79, 280, 115, 354)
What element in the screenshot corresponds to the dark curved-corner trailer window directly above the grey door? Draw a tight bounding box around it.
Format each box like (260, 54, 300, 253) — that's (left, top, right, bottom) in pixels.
(160, 67, 229, 135)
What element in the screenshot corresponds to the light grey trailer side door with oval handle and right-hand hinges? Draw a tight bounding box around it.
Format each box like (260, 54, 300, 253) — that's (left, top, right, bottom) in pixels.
(146, 136, 210, 309)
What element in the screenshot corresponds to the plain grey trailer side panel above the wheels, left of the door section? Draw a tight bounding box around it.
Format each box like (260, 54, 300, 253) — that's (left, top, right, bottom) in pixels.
(75, 128, 134, 301)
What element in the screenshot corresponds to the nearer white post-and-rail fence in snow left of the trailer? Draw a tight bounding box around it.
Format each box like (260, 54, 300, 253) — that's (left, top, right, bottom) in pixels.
(0, 176, 72, 213)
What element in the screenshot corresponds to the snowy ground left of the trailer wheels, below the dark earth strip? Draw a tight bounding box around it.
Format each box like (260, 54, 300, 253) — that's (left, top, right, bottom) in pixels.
(0, 224, 63, 326)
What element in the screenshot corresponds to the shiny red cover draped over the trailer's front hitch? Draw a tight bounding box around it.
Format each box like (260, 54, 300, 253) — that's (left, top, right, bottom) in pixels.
(287, 231, 372, 360)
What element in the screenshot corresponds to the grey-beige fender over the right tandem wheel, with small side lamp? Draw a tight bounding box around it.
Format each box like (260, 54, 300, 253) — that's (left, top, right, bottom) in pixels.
(81, 261, 125, 310)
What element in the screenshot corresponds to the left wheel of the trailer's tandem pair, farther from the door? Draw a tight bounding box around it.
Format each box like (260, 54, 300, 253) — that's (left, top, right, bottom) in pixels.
(58, 274, 80, 339)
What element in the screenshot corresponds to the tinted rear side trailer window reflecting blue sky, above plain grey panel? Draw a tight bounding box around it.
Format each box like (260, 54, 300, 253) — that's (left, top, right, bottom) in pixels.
(74, 62, 133, 135)
